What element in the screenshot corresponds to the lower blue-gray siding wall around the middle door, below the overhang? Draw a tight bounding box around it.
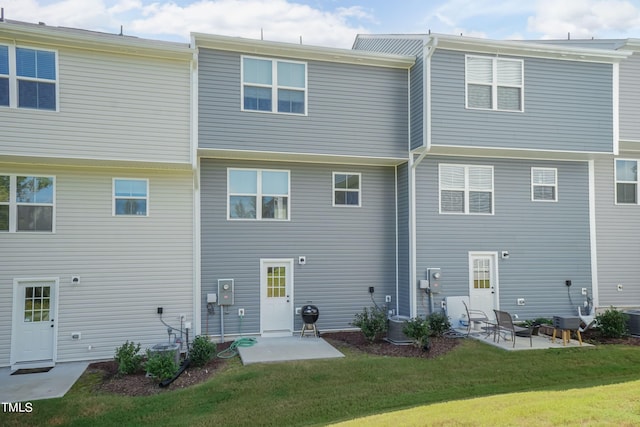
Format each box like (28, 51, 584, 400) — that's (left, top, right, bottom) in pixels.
(200, 159, 396, 335)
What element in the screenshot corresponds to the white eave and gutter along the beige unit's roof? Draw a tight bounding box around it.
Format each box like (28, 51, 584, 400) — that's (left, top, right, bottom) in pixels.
(0, 20, 194, 60)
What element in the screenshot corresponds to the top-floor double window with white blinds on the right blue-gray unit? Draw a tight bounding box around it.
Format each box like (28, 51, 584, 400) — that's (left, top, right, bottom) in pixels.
(465, 55, 524, 111)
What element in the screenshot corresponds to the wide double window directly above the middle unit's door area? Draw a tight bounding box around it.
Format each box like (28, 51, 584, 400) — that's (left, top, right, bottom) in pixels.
(227, 169, 289, 220)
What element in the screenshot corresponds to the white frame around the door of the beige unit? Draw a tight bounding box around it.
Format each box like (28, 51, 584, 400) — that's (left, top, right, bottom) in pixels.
(9, 277, 60, 369)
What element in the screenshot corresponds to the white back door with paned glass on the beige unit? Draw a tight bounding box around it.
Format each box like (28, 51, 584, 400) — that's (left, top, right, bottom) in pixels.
(11, 279, 58, 367)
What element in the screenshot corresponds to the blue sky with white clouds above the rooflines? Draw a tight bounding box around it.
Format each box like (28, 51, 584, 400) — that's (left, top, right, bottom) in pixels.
(0, 0, 640, 48)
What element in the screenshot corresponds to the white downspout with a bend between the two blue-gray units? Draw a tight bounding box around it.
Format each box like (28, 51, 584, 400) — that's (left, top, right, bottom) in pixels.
(409, 37, 438, 317)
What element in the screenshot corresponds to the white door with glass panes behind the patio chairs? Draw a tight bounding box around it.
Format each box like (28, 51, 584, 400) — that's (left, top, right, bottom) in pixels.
(469, 252, 500, 319)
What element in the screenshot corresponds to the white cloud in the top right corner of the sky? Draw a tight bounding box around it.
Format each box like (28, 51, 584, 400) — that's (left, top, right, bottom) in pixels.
(528, 0, 640, 39)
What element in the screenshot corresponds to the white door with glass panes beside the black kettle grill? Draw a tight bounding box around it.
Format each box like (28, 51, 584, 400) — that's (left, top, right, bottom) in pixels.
(260, 259, 293, 336)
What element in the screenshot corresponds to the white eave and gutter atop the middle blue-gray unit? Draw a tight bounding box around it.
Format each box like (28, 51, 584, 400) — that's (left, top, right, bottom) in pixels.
(191, 33, 415, 69)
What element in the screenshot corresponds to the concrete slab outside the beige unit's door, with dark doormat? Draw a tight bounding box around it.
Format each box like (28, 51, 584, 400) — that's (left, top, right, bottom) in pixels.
(0, 362, 90, 402)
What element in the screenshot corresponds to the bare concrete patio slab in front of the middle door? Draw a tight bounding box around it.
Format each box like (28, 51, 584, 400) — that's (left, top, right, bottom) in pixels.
(238, 336, 344, 365)
